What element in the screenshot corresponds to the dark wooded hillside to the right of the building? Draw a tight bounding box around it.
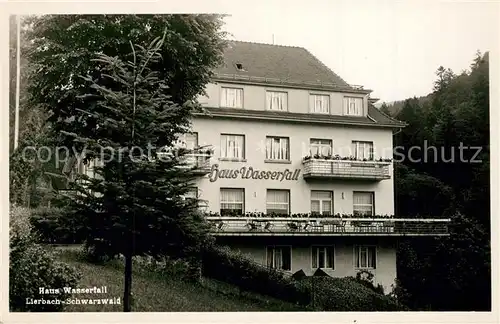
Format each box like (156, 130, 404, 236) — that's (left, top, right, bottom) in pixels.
(388, 53, 491, 311)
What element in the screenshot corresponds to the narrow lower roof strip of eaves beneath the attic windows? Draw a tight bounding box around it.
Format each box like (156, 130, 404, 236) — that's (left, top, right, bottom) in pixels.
(195, 105, 405, 128)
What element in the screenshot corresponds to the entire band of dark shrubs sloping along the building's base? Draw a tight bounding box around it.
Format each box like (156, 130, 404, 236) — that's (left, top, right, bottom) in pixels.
(202, 246, 407, 311)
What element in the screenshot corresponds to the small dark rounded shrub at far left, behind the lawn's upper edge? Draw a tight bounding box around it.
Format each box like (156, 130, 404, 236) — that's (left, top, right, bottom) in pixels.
(30, 207, 85, 244)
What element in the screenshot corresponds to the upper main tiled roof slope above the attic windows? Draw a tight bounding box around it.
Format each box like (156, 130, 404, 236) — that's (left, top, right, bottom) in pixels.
(214, 41, 354, 90)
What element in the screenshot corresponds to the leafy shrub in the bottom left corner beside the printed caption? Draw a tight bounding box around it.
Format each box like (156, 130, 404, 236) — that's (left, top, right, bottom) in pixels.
(9, 206, 79, 312)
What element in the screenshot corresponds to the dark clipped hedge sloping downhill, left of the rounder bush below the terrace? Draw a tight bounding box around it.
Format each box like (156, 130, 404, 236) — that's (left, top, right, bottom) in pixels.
(202, 245, 311, 305)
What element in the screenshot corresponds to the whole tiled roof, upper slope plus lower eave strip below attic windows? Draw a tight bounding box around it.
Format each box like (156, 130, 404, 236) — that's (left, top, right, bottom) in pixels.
(203, 41, 406, 128)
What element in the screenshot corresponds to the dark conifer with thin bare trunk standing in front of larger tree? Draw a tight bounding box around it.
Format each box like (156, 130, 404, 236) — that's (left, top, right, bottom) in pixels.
(66, 32, 213, 311)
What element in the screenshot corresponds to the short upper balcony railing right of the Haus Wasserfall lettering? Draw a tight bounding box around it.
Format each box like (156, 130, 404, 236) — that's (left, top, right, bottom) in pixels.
(302, 158, 391, 181)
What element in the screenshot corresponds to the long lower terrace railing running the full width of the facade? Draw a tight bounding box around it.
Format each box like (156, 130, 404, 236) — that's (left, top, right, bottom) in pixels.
(206, 216, 450, 236)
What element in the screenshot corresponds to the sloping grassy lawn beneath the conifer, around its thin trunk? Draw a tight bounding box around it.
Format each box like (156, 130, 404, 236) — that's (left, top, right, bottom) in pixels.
(53, 248, 305, 312)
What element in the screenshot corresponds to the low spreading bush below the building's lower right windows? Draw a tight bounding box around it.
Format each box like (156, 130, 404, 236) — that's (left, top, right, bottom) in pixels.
(300, 276, 408, 312)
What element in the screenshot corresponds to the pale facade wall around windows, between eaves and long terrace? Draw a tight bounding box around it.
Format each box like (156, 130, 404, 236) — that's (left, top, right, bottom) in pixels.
(193, 118, 394, 215)
